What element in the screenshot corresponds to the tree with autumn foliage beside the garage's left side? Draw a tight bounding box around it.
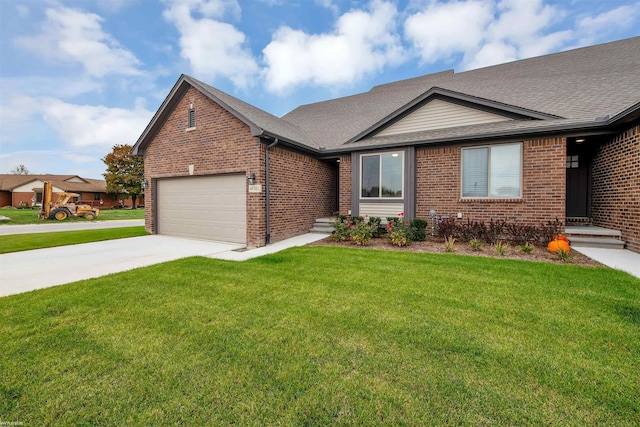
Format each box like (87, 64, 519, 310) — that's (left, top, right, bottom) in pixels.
(102, 144, 144, 209)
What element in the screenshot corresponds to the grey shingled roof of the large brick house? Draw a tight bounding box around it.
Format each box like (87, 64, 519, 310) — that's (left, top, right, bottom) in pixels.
(132, 37, 640, 154)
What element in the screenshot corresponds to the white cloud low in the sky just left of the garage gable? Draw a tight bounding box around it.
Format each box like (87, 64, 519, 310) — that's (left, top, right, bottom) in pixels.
(40, 98, 153, 150)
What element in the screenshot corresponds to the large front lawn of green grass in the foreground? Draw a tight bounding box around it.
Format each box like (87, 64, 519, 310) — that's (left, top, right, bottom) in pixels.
(0, 247, 640, 426)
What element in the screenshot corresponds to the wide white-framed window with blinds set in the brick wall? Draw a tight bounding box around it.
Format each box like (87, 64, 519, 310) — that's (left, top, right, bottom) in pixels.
(462, 144, 522, 198)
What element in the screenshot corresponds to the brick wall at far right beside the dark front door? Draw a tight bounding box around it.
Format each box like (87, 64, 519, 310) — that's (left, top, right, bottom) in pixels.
(591, 126, 640, 252)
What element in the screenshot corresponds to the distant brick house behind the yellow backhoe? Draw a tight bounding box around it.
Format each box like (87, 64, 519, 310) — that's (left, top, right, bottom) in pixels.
(0, 174, 142, 209)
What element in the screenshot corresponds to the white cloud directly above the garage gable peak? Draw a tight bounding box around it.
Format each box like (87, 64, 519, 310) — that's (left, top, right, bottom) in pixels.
(163, 0, 258, 87)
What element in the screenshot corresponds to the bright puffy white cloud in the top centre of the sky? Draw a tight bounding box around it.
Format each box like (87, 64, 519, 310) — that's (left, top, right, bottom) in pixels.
(263, 0, 404, 93)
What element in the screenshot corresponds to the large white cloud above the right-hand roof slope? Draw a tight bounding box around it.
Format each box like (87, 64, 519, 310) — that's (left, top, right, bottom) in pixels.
(405, 0, 575, 69)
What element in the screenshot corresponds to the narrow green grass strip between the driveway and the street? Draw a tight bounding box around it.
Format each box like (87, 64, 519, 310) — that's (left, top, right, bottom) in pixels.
(0, 226, 148, 254)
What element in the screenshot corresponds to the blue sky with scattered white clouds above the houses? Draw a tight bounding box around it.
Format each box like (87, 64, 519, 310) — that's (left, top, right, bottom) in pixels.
(0, 0, 640, 179)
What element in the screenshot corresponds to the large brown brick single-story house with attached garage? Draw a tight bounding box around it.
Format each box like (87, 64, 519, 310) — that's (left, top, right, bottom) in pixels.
(132, 37, 640, 251)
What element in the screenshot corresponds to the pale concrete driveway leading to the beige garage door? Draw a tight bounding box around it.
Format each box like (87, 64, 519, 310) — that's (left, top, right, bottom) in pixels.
(0, 236, 244, 297)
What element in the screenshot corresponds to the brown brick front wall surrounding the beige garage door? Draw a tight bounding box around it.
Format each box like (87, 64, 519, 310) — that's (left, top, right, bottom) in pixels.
(144, 88, 265, 246)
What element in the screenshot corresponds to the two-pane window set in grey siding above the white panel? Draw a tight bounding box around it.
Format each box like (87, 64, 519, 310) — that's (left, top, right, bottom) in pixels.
(360, 152, 404, 198)
